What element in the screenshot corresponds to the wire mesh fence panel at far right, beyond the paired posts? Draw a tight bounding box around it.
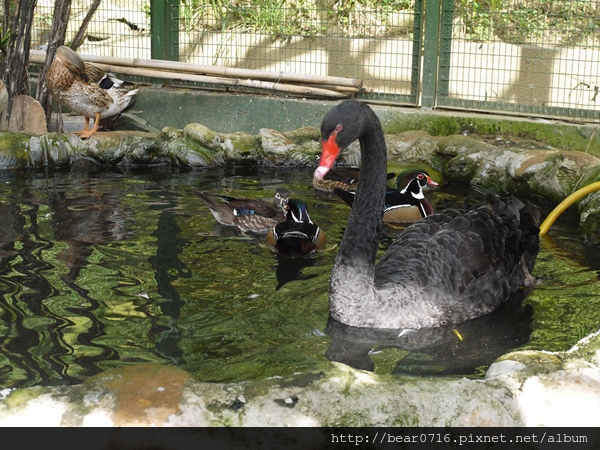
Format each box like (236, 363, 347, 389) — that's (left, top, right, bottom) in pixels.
(437, 0, 600, 118)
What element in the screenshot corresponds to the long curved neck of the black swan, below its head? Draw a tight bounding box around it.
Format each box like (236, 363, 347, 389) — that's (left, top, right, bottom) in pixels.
(329, 124, 387, 326)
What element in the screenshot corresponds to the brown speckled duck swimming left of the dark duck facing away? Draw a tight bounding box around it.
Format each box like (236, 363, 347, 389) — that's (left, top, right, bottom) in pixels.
(195, 188, 289, 233)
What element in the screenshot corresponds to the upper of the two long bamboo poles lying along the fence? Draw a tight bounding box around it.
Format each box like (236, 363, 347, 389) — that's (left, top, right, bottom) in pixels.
(31, 50, 363, 89)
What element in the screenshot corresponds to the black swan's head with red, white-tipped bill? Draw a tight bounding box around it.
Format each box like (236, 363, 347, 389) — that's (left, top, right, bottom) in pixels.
(314, 100, 374, 180)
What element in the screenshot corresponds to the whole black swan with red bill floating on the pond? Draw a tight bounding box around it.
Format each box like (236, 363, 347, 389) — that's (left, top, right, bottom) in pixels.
(314, 100, 540, 329)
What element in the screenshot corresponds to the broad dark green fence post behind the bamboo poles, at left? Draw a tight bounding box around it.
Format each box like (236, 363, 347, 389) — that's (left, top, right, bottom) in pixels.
(150, 0, 179, 61)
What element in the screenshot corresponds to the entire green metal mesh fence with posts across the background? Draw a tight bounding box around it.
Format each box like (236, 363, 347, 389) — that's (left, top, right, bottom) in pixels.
(33, 0, 600, 119)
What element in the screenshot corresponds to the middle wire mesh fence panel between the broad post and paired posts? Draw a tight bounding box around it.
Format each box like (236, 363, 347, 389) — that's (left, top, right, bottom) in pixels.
(180, 0, 420, 103)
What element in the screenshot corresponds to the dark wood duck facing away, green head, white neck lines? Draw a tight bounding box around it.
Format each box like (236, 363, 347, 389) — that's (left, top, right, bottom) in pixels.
(267, 199, 326, 258)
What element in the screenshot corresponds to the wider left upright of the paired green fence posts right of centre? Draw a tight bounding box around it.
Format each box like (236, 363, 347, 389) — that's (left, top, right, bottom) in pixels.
(421, 0, 442, 109)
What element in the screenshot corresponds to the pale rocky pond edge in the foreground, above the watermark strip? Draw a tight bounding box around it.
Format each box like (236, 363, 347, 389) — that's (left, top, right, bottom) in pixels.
(0, 331, 600, 427)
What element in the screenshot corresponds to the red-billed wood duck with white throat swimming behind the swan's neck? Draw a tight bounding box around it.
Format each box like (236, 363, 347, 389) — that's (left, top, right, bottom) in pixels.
(333, 172, 438, 224)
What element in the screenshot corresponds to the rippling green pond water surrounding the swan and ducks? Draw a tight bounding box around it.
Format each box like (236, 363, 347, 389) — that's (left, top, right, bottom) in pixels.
(0, 168, 600, 389)
